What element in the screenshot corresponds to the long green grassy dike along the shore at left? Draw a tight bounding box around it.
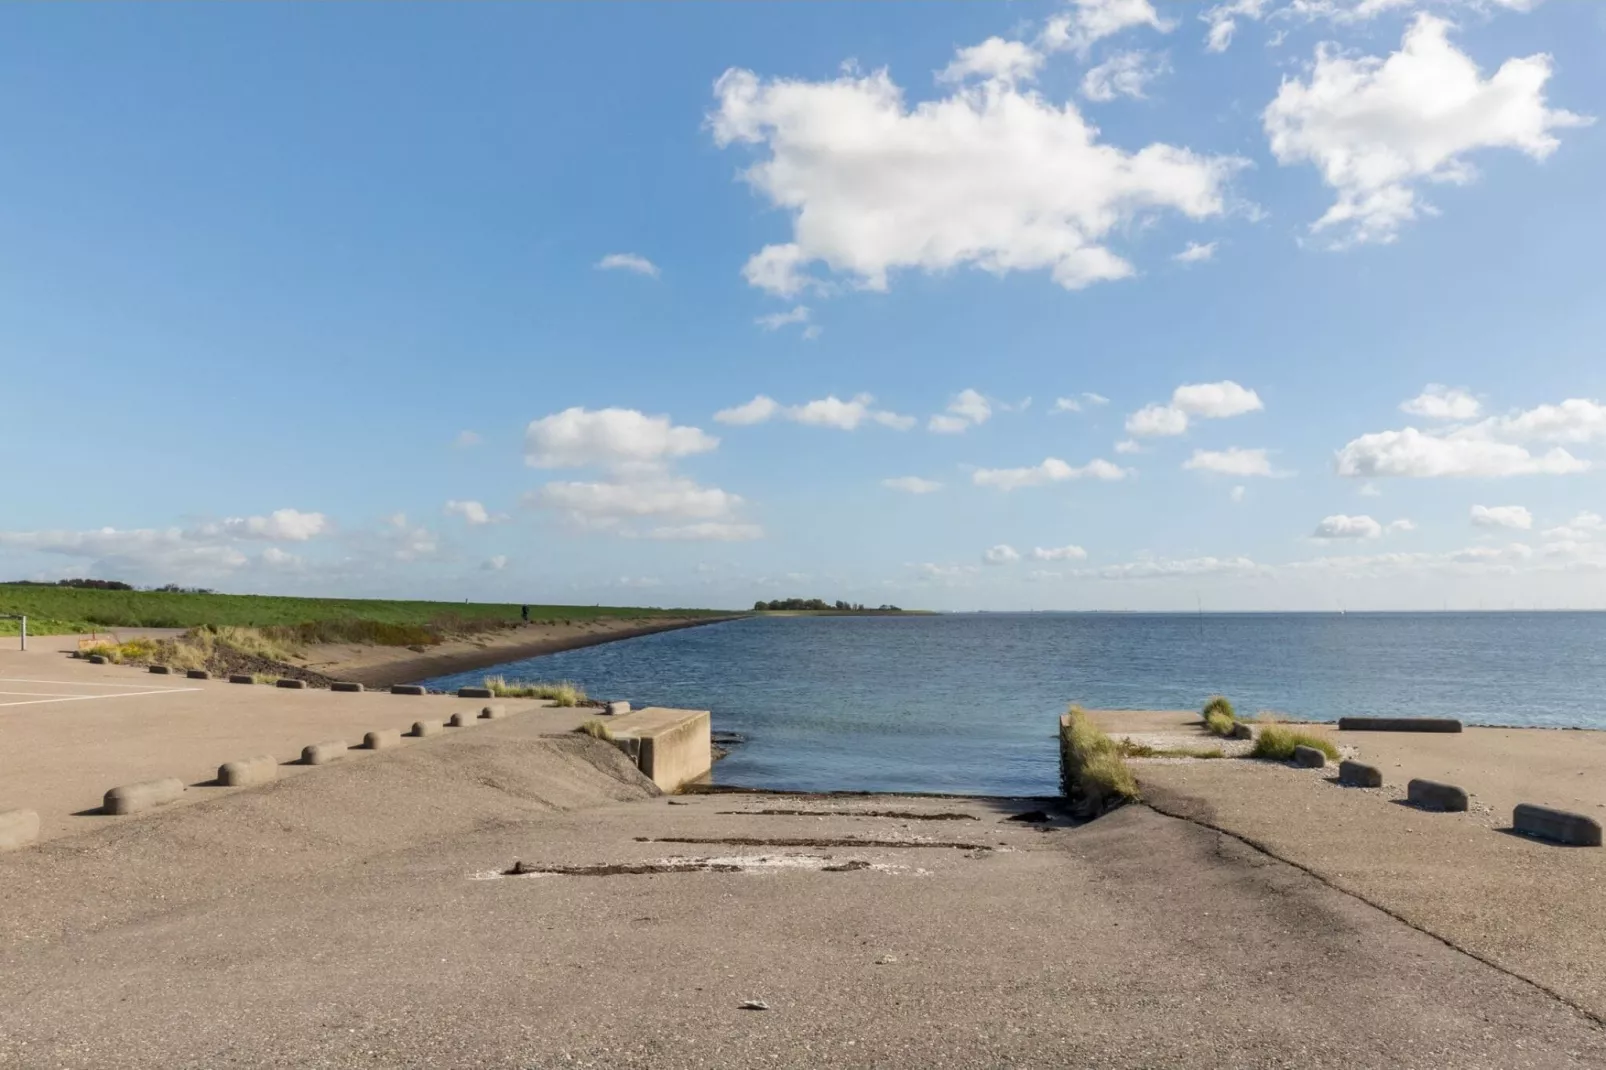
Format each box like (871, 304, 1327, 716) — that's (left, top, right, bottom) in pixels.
(0, 583, 731, 646)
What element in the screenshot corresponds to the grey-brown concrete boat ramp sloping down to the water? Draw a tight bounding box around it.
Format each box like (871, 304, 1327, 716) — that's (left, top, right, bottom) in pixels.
(9, 655, 1606, 1068)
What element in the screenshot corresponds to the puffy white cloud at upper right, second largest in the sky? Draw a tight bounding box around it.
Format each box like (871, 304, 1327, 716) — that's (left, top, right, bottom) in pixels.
(1262, 13, 1590, 246)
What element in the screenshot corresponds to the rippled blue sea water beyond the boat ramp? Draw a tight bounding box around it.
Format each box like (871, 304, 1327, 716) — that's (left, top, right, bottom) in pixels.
(429, 612, 1606, 794)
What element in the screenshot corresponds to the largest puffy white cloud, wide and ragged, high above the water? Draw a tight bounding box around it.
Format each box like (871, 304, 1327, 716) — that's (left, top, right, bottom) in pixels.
(708, 43, 1243, 296)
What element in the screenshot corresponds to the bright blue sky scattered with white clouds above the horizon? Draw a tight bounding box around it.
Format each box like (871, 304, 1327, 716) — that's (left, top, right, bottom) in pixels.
(0, 0, 1606, 609)
